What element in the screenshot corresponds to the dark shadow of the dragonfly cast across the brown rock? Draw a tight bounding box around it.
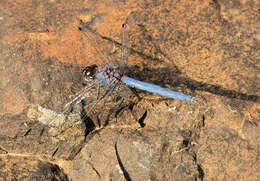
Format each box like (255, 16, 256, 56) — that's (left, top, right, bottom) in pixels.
(76, 22, 260, 103)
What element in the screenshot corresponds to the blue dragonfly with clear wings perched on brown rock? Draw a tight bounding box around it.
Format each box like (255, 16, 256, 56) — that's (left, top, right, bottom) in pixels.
(52, 23, 195, 126)
